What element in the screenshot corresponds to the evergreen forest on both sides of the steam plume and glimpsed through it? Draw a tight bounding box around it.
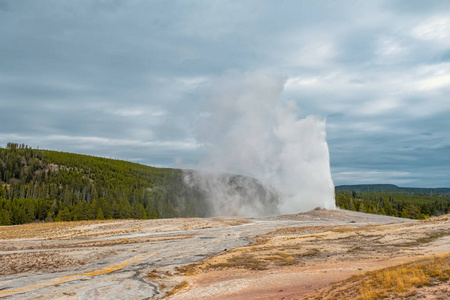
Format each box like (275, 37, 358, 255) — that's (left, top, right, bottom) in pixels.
(0, 143, 450, 225)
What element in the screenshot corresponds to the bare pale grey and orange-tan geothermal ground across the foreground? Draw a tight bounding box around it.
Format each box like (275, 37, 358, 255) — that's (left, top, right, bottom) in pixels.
(0, 209, 450, 299)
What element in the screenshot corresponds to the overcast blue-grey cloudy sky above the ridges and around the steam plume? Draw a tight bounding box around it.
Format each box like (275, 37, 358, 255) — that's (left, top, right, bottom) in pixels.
(0, 0, 450, 187)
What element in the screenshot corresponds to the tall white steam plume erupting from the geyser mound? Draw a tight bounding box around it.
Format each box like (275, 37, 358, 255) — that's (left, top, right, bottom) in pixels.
(188, 72, 335, 216)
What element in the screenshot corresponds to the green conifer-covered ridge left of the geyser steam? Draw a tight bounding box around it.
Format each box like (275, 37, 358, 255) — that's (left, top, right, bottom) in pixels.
(0, 143, 209, 225)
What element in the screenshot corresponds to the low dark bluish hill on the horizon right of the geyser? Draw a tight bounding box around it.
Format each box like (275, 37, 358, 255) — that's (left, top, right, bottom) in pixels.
(335, 184, 450, 196)
